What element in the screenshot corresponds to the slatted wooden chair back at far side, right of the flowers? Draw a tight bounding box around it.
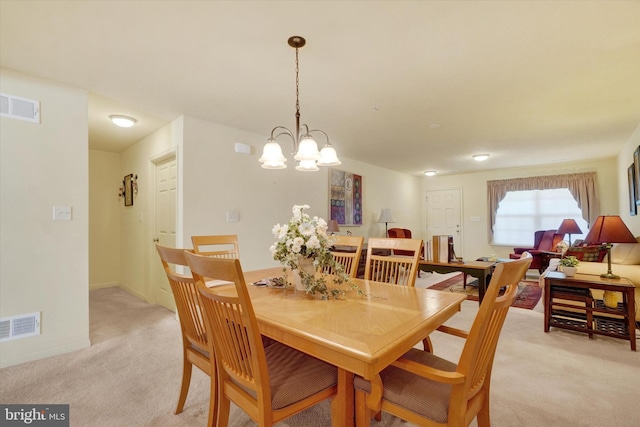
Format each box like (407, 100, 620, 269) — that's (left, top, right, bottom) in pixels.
(364, 237, 422, 286)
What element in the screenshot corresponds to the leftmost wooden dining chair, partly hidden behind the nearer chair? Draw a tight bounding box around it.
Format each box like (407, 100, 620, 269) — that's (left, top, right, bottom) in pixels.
(156, 245, 216, 425)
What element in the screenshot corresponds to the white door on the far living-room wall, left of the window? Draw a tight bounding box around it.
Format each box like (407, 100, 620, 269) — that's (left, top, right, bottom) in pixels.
(427, 189, 464, 257)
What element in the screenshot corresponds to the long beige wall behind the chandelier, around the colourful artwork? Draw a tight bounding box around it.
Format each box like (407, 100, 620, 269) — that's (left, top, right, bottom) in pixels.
(182, 117, 420, 269)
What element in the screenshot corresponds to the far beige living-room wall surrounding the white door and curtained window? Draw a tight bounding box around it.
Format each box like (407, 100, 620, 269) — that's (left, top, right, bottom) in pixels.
(422, 157, 626, 259)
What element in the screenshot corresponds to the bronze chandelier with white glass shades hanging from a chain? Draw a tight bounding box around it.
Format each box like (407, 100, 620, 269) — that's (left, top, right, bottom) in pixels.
(259, 36, 342, 172)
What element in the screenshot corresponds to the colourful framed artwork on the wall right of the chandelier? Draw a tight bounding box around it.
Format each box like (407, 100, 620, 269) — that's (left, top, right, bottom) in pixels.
(329, 169, 362, 226)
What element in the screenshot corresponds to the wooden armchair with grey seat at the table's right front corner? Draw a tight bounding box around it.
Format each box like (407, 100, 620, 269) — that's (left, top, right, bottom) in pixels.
(354, 258, 531, 427)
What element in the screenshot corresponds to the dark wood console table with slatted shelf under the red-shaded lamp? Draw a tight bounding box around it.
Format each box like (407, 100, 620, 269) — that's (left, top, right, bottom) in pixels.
(544, 271, 636, 351)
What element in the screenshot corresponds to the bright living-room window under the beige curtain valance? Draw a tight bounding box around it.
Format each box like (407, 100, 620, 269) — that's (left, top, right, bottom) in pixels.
(493, 188, 589, 247)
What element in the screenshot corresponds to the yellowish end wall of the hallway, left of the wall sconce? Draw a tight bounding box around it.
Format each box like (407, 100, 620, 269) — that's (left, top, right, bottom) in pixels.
(89, 150, 124, 289)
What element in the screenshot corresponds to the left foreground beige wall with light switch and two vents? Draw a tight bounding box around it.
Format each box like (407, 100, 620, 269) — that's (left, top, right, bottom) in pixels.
(0, 69, 89, 367)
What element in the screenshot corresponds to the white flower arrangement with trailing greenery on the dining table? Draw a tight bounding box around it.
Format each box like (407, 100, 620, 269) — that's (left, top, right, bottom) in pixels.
(269, 205, 359, 298)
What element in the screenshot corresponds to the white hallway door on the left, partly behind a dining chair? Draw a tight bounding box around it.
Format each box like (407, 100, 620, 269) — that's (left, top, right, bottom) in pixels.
(152, 157, 177, 312)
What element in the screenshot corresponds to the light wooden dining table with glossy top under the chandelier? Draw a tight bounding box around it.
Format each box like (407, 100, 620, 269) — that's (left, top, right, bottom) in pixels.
(228, 267, 466, 426)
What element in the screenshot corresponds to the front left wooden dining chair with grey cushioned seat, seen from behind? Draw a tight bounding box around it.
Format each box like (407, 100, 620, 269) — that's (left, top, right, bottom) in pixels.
(185, 253, 338, 427)
